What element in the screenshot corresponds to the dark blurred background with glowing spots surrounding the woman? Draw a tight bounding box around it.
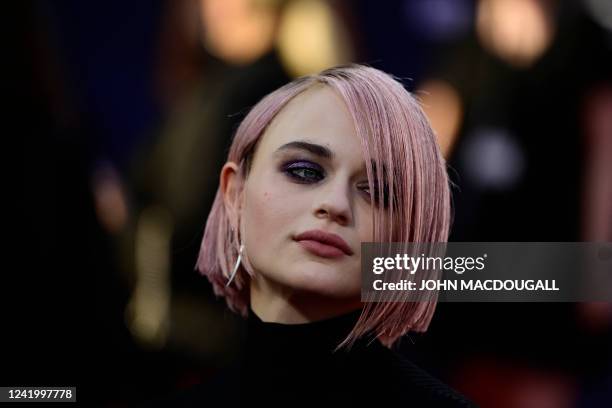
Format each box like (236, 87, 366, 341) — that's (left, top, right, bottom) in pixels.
(0, 0, 612, 408)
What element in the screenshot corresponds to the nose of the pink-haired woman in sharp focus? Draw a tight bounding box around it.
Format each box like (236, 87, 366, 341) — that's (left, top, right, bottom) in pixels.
(315, 180, 353, 225)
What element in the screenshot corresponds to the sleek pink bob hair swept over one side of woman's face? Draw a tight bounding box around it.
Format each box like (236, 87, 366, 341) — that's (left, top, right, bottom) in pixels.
(196, 64, 451, 347)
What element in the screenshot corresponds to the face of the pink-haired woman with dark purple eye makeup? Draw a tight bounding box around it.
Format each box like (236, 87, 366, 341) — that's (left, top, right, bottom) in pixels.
(234, 84, 373, 306)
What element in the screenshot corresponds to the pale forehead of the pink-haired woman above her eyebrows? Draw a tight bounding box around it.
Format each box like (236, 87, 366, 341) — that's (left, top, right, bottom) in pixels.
(260, 84, 363, 162)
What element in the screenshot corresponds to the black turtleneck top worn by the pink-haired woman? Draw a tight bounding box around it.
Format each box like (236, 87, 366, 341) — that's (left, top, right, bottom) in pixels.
(147, 311, 474, 407)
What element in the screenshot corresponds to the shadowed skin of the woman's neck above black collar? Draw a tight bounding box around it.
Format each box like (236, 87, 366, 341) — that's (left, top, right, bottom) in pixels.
(250, 275, 362, 324)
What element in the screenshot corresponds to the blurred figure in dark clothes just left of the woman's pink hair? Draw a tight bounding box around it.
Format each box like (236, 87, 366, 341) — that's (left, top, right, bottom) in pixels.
(120, 0, 289, 376)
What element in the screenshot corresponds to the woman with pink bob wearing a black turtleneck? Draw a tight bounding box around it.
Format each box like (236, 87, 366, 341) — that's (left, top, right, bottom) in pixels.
(197, 65, 470, 406)
